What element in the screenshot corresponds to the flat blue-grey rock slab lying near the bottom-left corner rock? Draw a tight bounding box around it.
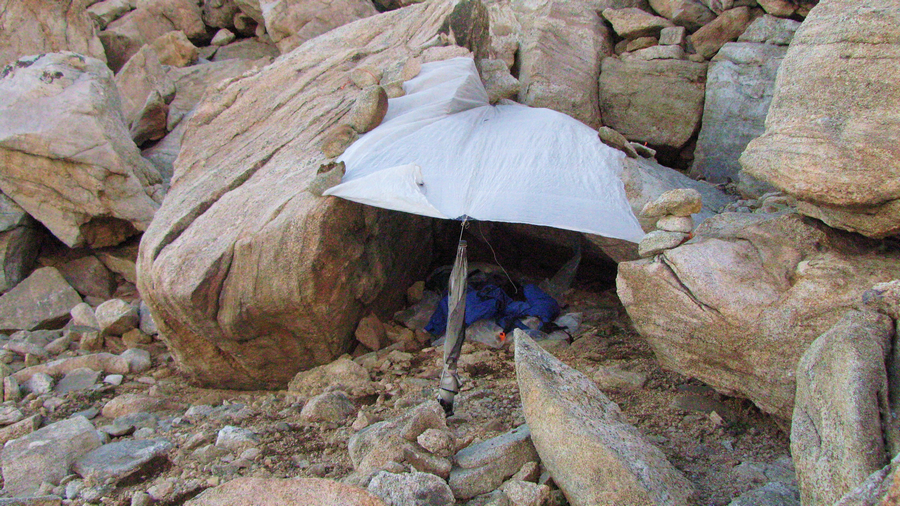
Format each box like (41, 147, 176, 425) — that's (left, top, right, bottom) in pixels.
(73, 438, 173, 484)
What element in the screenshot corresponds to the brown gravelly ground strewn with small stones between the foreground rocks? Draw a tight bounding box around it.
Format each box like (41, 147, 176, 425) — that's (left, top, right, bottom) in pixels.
(5, 268, 795, 505)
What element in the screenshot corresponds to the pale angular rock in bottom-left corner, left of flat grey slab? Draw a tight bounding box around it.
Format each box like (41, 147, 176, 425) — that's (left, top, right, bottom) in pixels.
(0, 416, 100, 496)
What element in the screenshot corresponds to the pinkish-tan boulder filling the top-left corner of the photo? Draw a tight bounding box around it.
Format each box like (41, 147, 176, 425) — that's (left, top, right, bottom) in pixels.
(0, 0, 106, 67)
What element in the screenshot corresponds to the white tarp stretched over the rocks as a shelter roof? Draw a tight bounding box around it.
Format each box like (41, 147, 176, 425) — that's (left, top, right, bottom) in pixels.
(325, 58, 644, 242)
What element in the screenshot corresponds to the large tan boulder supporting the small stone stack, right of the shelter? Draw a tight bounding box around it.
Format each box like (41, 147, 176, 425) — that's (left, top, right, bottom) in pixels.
(617, 213, 900, 420)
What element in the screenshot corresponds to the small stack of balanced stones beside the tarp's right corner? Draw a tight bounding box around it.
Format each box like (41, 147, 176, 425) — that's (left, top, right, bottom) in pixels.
(638, 188, 703, 258)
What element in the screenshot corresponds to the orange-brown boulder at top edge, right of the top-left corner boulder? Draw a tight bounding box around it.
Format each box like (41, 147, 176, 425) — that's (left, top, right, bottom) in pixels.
(100, 0, 207, 72)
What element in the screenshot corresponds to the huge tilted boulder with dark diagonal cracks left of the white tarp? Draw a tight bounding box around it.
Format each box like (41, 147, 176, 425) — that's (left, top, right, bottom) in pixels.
(138, 1, 487, 388)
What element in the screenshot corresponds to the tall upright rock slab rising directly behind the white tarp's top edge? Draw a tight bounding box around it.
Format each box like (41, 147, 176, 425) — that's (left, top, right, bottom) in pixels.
(513, 0, 612, 128)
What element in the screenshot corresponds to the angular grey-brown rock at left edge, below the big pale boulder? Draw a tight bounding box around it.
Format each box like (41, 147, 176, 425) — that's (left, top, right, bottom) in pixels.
(0, 267, 81, 332)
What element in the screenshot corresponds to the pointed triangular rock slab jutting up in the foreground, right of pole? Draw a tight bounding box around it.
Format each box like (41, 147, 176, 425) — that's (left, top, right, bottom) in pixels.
(515, 330, 694, 506)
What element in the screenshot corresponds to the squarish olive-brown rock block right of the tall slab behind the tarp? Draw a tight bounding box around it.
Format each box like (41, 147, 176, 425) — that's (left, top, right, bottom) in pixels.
(600, 58, 707, 149)
